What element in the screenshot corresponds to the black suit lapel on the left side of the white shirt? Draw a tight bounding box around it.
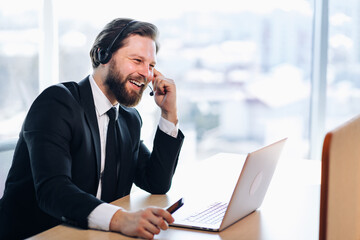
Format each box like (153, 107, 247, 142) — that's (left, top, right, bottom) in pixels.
(79, 77, 101, 179)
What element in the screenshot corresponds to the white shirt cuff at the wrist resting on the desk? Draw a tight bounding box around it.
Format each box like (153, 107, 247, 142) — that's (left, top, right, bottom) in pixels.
(88, 203, 121, 231)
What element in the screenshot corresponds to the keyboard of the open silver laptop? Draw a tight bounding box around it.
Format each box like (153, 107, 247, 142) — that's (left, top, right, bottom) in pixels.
(185, 202, 228, 224)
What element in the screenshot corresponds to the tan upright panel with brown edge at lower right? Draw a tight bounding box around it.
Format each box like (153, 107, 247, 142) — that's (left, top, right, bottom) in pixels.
(319, 116, 360, 240)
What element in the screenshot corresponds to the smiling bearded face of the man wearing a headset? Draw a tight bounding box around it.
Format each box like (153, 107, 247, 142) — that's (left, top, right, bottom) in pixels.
(105, 35, 156, 107)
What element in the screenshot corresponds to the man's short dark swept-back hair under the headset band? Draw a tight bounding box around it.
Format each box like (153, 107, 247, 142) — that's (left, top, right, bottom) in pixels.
(90, 18, 159, 68)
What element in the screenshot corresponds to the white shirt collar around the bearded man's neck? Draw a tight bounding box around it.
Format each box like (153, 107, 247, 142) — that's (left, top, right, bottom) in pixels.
(89, 75, 119, 119)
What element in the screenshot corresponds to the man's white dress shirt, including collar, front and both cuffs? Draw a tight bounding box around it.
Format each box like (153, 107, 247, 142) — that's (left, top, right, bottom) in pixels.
(88, 75, 179, 231)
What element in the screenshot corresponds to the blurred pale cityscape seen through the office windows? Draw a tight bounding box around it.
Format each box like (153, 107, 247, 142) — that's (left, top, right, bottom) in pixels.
(0, 0, 360, 160)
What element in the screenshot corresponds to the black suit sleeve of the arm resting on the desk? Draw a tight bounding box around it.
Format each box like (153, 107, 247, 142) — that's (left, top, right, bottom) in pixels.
(23, 86, 102, 228)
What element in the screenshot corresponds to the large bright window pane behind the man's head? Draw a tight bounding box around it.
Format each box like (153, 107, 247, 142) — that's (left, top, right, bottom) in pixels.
(56, 0, 313, 159)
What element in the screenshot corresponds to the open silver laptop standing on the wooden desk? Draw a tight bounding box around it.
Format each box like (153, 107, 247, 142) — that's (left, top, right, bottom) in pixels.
(170, 138, 286, 232)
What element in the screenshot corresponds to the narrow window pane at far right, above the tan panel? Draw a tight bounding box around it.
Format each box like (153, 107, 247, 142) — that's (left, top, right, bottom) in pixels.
(326, 0, 360, 130)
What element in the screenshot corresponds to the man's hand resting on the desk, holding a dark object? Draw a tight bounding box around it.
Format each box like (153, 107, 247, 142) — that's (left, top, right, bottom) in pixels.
(110, 207, 174, 239)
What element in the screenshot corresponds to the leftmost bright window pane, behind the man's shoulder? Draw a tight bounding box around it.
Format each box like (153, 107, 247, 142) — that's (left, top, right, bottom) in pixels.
(0, 1, 41, 142)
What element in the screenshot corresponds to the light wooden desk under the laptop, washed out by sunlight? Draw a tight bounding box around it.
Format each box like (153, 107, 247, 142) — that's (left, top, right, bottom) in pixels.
(31, 155, 321, 240)
